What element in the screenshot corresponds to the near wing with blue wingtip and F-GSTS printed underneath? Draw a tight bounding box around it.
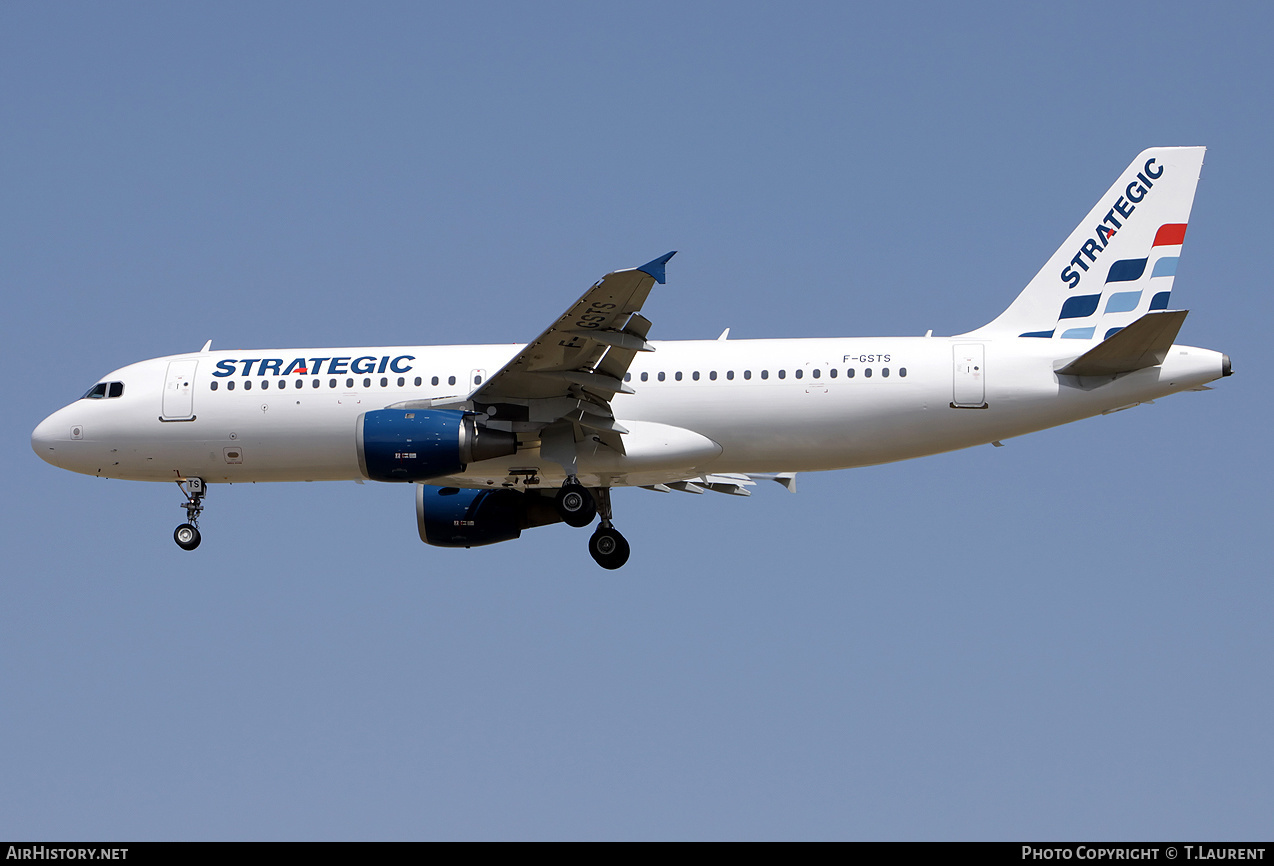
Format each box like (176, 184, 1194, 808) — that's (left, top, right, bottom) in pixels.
(465, 250, 676, 450)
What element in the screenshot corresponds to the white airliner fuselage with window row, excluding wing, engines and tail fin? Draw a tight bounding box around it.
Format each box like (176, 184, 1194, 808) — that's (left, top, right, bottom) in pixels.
(32, 337, 1223, 486)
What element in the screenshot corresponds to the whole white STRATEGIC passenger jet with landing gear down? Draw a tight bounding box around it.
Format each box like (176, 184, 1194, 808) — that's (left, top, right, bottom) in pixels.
(31, 146, 1232, 569)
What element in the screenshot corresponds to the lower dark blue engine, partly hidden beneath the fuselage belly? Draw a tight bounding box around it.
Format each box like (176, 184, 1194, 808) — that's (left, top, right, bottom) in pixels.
(415, 484, 562, 548)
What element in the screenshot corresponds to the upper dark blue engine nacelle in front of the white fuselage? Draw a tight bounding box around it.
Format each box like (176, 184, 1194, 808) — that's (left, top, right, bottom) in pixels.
(354, 409, 517, 481)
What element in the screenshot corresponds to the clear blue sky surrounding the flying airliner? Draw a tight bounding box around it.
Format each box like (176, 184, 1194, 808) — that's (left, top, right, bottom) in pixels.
(0, 3, 1274, 841)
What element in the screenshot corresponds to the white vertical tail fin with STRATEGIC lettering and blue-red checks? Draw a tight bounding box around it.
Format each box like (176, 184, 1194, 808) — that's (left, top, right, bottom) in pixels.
(964, 148, 1205, 340)
